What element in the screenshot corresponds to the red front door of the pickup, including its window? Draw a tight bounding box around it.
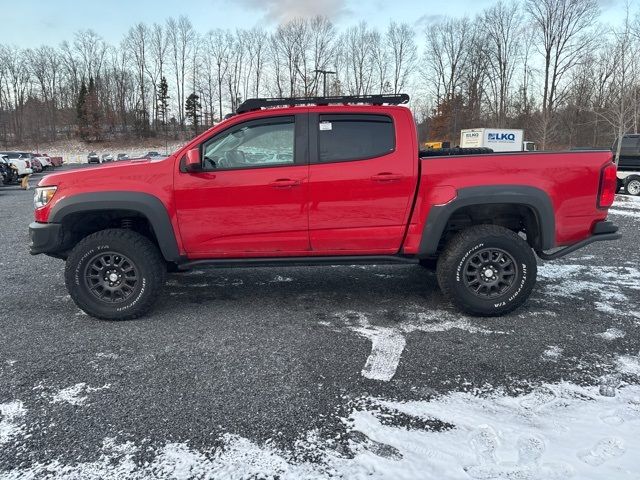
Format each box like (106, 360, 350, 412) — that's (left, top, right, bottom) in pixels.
(175, 114, 309, 258)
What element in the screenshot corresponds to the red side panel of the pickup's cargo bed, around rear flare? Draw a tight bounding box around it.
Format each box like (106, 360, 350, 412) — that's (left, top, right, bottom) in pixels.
(403, 151, 611, 254)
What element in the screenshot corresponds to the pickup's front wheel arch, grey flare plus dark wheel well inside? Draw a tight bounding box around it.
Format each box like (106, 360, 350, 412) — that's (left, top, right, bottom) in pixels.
(49, 191, 180, 262)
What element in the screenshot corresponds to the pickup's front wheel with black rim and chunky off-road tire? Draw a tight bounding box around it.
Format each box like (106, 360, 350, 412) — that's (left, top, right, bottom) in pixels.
(65, 229, 166, 320)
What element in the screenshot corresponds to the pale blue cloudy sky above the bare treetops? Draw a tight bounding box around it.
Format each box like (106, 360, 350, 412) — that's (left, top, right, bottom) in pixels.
(0, 0, 640, 47)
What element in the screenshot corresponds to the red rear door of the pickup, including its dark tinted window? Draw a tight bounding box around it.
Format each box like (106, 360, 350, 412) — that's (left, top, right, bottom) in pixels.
(309, 113, 417, 255)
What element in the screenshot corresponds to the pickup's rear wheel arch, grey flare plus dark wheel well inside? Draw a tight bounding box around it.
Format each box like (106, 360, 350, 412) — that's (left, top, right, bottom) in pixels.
(418, 185, 555, 258)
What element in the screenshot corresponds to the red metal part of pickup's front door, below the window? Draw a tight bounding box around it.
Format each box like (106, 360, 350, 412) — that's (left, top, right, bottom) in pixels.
(174, 165, 309, 258)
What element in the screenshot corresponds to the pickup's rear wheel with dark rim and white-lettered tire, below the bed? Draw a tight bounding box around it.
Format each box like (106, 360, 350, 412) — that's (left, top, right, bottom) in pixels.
(437, 225, 537, 316)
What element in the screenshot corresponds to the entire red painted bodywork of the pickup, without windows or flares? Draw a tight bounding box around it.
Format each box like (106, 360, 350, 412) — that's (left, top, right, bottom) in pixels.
(35, 106, 611, 259)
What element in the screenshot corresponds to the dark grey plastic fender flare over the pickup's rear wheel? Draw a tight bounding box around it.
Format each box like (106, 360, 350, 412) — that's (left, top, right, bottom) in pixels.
(418, 185, 556, 257)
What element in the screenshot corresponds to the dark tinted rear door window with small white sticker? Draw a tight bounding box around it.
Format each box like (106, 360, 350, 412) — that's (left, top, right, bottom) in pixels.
(318, 115, 396, 163)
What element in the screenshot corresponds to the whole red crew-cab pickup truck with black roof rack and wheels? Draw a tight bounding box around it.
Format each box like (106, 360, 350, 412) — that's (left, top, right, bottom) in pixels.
(29, 95, 620, 319)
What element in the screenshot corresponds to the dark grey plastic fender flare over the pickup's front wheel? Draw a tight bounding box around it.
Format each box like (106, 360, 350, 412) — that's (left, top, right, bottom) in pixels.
(49, 191, 180, 262)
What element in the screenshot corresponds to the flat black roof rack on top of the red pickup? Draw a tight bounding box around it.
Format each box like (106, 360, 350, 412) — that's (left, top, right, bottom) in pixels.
(236, 93, 409, 113)
